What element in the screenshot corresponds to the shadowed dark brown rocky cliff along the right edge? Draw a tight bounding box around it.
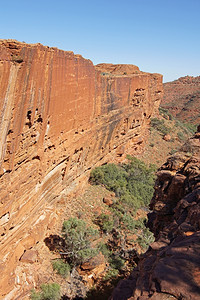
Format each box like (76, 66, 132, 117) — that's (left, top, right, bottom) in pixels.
(112, 132, 200, 300)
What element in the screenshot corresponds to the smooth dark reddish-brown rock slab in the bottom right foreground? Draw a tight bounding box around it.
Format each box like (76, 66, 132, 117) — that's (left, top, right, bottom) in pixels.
(111, 232, 200, 300)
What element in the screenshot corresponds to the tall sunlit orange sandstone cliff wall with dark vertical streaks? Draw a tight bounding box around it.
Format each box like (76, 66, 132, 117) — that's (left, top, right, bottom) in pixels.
(0, 40, 162, 299)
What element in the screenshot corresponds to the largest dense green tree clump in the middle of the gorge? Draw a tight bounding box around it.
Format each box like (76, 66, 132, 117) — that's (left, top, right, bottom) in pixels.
(90, 156, 155, 208)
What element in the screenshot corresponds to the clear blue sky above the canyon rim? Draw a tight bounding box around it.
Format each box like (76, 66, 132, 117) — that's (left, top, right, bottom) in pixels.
(0, 0, 200, 81)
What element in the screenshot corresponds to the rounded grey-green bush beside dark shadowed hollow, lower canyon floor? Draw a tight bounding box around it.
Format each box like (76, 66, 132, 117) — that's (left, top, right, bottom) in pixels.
(62, 218, 97, 266)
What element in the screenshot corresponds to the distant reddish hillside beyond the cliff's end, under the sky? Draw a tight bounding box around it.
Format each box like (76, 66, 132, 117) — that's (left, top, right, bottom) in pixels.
(161, 76, 200, 124)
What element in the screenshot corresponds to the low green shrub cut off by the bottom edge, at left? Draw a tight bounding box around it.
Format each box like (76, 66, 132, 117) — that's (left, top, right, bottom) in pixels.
(31, 283, 60, 300)
